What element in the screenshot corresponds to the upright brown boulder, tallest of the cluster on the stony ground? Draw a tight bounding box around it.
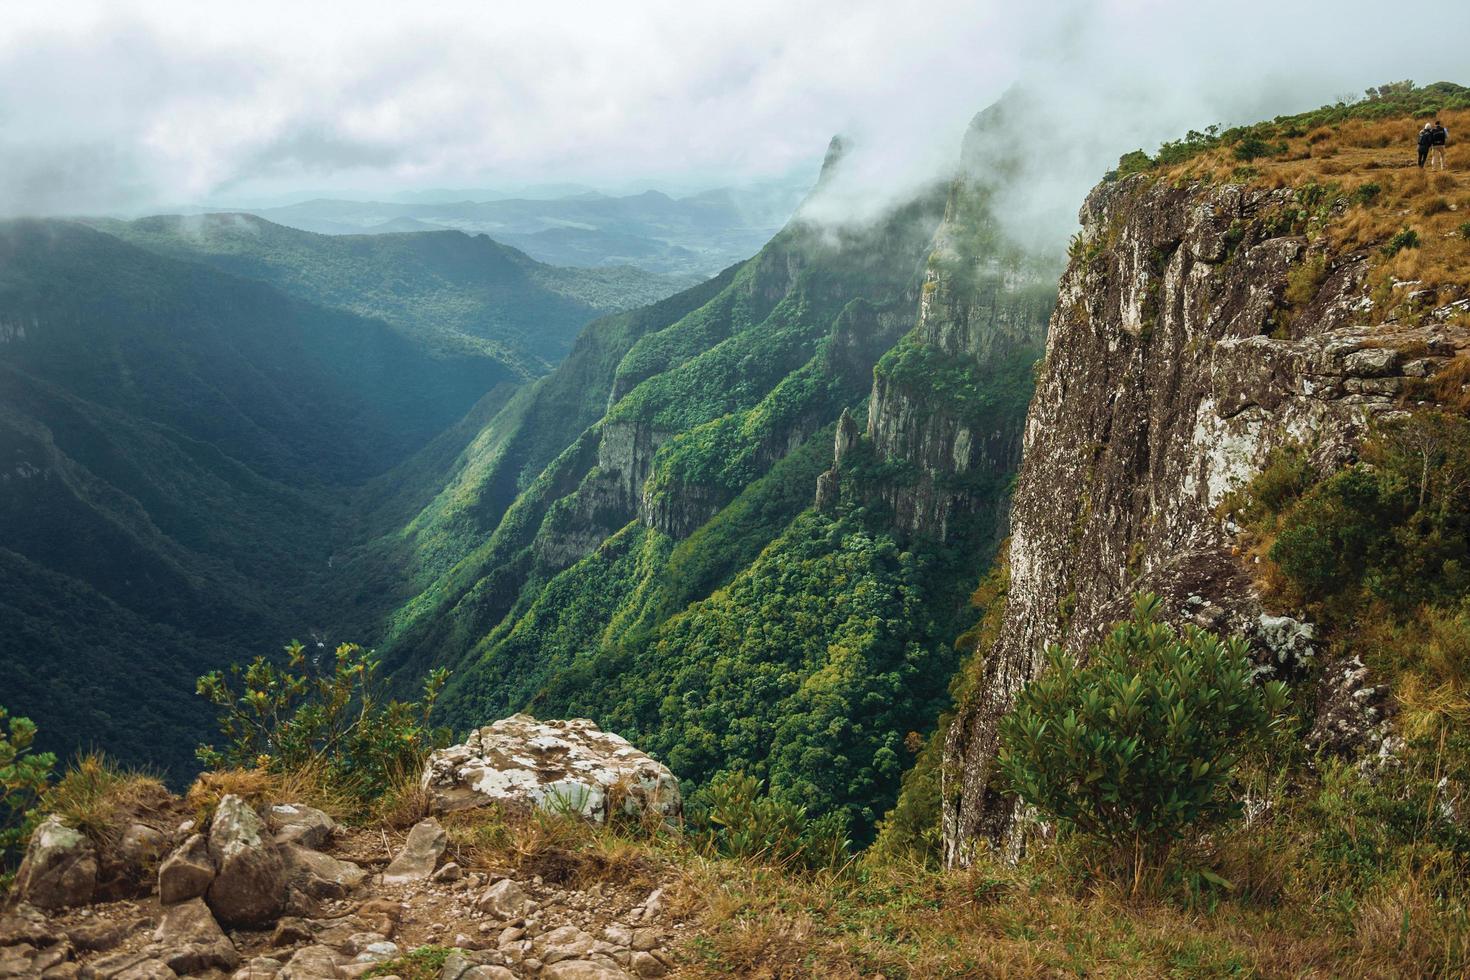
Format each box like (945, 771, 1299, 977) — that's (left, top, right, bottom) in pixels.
(207, 793, 287, 926)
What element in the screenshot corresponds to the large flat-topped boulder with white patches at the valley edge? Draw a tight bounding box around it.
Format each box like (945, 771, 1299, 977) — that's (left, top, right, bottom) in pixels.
(422, 714, 684, 823)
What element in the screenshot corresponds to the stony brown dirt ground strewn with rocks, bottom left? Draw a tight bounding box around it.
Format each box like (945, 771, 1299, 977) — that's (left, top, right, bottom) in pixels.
(0, 807, 688, 980)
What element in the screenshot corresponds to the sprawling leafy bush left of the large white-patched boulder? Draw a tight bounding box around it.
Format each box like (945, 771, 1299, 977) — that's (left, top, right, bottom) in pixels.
(198, 642, 448, 804)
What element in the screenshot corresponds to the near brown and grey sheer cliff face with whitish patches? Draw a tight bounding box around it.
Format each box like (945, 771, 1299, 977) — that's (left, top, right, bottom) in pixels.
(944, 175, 1464, 864)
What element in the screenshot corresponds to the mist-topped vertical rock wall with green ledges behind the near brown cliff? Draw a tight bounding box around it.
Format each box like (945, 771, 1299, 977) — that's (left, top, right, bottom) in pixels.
(823, 161, 1058, 542)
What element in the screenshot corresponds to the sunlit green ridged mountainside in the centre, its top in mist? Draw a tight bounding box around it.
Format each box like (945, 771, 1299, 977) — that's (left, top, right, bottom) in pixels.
(388, 119, 1055, 836)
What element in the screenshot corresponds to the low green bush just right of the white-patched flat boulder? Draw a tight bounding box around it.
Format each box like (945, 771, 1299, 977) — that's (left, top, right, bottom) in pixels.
(691, 773, 850, 868)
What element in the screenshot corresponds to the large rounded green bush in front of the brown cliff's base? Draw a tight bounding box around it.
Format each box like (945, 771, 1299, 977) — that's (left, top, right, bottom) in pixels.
(998, 595, 1286, 890)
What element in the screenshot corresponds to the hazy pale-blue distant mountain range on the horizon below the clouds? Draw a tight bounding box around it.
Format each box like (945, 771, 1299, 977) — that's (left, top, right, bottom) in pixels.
(201, 181, 810, 282)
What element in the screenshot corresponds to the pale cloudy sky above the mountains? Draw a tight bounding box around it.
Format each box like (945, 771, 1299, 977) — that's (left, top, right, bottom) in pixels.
(0, 0, 1470, 215)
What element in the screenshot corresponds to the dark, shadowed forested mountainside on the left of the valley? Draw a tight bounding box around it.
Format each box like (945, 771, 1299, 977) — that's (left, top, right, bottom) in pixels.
(0, 220, 637, 773)
